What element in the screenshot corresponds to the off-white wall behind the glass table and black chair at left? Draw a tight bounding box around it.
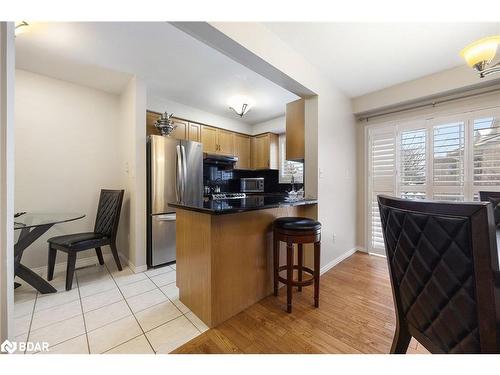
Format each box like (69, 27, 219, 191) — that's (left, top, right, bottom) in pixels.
(15, 70, 127, 267)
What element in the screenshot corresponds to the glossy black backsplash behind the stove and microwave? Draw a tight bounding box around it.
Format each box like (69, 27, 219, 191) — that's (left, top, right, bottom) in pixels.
(203, 165, 304, 193)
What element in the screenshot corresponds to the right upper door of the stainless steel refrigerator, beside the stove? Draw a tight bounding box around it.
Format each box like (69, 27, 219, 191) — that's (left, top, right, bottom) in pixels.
(180, 141, 203, 206)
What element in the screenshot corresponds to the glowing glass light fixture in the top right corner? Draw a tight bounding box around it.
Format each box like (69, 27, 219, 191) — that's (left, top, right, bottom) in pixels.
(460, 35, 500, 78)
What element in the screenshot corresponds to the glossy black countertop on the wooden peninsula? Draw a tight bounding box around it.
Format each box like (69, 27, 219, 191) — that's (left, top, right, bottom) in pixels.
(169, 195, 318, 215)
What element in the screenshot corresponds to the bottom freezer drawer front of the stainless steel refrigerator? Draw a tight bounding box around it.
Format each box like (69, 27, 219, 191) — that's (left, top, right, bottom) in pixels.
(151, 213, 176, 267)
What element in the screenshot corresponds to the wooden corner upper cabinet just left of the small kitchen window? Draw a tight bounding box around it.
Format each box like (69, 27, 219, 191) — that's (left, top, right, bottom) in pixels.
(250, 133, 279, 169)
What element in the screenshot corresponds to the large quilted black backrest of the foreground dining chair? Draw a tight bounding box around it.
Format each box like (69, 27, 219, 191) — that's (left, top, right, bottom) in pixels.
(378, 195, 500, 353)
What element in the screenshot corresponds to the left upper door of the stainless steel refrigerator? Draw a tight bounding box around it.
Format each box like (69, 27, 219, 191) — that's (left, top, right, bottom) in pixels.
(149, 135, 180, 214)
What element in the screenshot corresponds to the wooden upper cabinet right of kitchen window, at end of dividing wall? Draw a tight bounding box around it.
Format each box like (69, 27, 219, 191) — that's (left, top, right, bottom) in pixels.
(286, 99, 305, 161)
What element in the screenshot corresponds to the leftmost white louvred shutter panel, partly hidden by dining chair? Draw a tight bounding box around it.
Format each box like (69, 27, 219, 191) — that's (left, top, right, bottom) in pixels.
(368, 128, 396, 255)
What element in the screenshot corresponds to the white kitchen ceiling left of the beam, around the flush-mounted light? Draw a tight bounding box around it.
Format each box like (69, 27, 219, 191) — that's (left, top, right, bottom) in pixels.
(16, 22, 297, 124)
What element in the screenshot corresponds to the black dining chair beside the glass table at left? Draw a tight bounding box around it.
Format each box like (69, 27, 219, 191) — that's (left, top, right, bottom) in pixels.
(47, 189, 124, 290)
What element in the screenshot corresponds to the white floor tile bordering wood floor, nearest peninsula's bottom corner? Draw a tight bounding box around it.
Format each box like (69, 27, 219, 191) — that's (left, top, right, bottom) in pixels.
(146, 316, 200, 354)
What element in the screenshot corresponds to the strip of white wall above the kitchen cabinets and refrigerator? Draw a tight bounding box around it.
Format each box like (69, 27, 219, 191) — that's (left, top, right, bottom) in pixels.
(147, 94, 252, 134)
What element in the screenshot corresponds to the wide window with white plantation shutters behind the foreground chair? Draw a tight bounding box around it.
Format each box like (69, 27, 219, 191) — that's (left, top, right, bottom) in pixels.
(367, 109, 500, 253)
